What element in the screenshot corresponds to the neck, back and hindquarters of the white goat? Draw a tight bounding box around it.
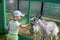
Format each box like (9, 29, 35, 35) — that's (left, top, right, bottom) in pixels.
(38, 19, 59, 40)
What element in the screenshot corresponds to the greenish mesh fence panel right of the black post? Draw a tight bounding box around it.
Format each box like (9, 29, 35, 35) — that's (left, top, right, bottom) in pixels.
(43, 3, 60, 20)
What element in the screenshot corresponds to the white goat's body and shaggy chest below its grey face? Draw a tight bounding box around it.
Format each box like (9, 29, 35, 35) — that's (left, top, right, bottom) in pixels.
(30, 18, 59, 40)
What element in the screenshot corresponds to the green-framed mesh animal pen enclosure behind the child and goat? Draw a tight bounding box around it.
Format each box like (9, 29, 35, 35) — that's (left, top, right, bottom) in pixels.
(0, 0, 60, 40)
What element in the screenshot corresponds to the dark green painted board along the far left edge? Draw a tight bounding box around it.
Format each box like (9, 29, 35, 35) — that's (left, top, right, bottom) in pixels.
(0, 0, 4, 32)
